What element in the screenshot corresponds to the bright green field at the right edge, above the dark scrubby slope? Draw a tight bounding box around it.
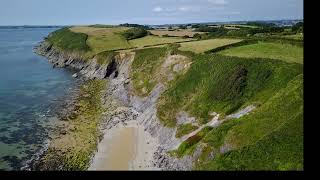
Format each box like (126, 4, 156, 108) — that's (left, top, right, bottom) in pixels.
(219, 42, 303, 64)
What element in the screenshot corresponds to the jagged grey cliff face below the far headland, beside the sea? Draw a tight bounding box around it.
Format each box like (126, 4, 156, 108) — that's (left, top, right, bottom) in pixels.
(34, 41, 118, 79)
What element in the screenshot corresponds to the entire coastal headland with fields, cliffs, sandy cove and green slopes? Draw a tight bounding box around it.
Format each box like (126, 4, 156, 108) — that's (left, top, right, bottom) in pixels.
(29, 27, 303, 170)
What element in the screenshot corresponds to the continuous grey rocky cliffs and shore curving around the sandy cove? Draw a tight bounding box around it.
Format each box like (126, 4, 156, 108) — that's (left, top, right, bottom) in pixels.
(31, 41, 201, 170)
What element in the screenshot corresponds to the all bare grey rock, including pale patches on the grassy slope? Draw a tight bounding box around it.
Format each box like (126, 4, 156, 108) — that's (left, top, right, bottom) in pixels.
(35, 41, 255, 170)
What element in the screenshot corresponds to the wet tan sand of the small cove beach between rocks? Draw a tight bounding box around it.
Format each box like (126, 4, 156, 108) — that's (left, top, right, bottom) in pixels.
(88, 121, 156, 170)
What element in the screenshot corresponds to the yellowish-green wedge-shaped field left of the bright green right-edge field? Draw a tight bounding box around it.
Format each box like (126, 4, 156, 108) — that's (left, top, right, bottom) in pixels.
(179, 39, 241, 53)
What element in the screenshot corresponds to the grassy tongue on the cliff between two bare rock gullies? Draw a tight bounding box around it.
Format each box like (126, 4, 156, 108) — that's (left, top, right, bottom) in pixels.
(131, 47, 167, 96)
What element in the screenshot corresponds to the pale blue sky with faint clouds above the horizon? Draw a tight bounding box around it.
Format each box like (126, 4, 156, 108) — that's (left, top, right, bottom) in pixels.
(0, 0, 303, 25)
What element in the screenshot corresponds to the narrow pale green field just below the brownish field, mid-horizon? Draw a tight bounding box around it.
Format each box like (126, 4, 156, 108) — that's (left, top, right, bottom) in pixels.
(129, 35, 193, 48)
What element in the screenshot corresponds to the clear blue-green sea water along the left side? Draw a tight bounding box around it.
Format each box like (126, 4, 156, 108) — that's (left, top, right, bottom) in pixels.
(0, 27, 77, 170)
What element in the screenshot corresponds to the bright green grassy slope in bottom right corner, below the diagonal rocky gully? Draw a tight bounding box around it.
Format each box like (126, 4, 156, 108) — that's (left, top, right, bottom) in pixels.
(196, 75, 303, 170)
